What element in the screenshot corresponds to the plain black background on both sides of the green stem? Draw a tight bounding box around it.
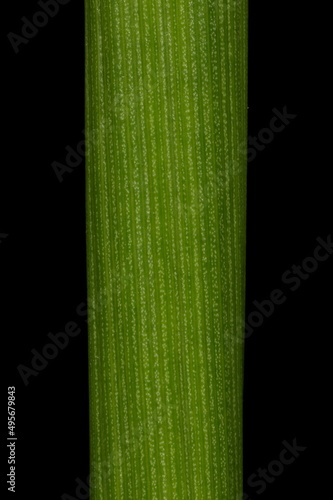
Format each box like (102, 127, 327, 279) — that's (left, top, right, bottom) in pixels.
(0, 0, 333, 500)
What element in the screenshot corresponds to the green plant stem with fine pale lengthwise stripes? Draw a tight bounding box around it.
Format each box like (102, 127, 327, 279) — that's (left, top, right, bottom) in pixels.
(85, 0, 247, 500)
